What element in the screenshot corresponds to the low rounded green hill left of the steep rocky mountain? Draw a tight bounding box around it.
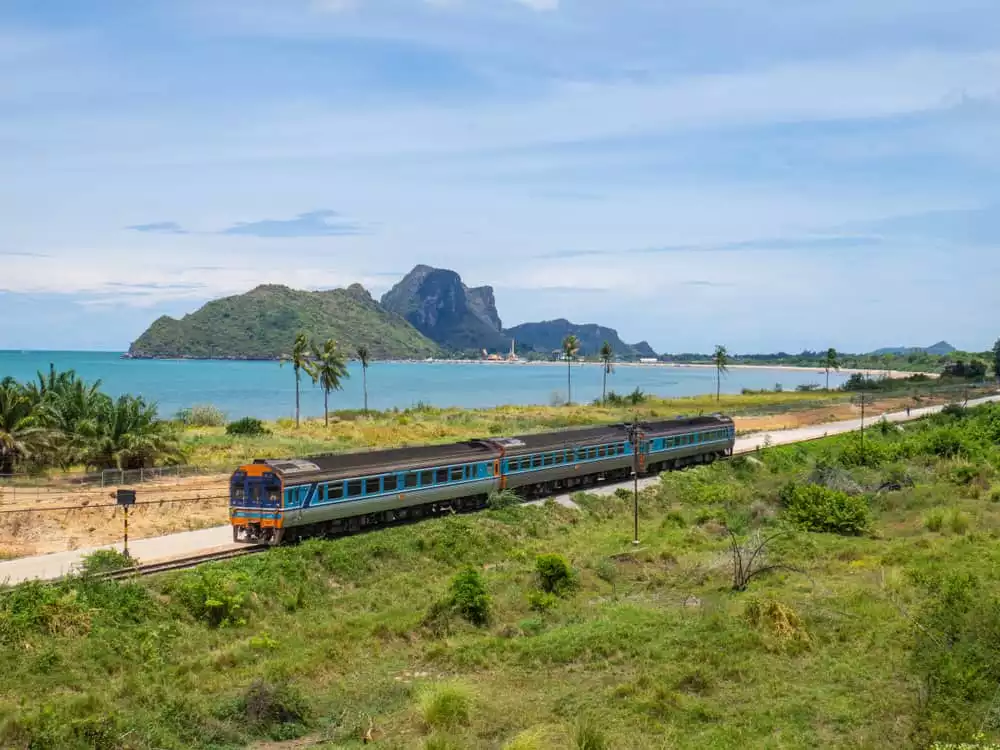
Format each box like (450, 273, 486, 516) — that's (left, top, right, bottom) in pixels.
(128, 284, 439, 359)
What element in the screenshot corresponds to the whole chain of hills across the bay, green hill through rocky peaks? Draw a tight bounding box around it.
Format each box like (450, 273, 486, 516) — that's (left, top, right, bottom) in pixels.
(124, 265, 657, 360)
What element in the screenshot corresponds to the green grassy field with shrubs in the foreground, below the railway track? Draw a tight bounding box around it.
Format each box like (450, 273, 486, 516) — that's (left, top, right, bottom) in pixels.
(0, 407, 1000, 750)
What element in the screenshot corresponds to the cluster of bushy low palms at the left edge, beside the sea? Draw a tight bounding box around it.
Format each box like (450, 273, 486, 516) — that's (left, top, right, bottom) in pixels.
(0, 368, 180, 475)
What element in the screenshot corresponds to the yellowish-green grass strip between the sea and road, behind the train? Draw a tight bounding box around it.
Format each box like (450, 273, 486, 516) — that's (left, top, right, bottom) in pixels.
(183, 391, 850, 466)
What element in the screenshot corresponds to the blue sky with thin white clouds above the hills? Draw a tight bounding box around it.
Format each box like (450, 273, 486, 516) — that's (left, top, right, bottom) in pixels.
(0, 0, 1000, 353)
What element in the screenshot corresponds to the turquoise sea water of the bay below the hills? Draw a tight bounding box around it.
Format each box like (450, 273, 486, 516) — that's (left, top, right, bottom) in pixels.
(0, 351, 845, 419)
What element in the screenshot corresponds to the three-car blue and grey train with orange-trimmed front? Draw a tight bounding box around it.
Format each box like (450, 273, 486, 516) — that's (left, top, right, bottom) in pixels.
(229, 414, 736, 545)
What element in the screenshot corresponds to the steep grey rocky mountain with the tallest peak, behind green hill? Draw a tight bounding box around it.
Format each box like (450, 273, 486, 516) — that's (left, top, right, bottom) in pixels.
(381, 265, 509, 352)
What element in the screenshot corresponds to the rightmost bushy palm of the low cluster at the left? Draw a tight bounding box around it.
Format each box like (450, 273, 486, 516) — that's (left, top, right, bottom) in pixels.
(82, 395, 182, 470)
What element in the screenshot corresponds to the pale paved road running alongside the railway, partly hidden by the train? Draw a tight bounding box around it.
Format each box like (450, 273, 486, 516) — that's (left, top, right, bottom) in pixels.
(0, 395, 1000, 584)
